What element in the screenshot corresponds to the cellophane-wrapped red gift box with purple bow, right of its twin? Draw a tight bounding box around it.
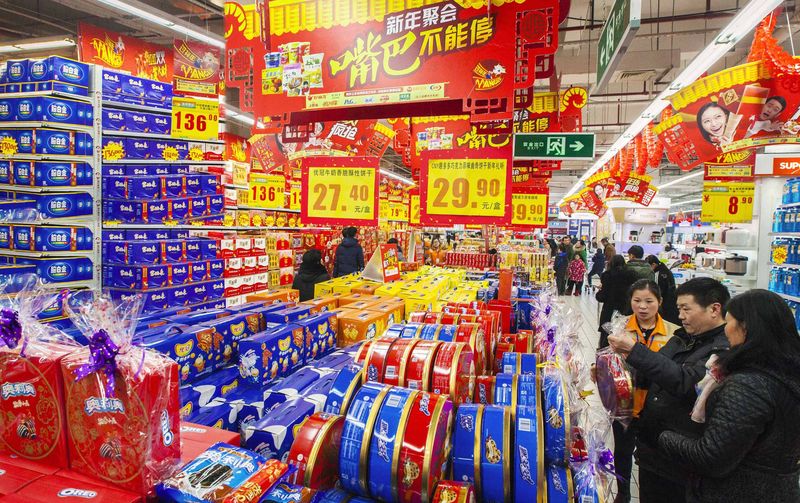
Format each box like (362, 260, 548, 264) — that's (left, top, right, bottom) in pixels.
(61, 295, 181, 494)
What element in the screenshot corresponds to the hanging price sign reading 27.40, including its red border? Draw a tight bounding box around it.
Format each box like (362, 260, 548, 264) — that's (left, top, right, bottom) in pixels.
(300, 157, 379, 225)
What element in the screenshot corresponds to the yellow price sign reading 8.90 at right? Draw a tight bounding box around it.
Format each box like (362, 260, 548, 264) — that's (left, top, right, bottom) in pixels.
(700, 182, 755, 223)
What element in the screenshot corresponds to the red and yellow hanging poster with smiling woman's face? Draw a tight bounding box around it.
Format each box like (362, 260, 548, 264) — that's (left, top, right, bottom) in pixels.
(654, 61, 800, 170)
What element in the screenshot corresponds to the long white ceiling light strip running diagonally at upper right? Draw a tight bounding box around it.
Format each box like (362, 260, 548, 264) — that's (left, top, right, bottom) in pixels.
(558, 0, 783, 205)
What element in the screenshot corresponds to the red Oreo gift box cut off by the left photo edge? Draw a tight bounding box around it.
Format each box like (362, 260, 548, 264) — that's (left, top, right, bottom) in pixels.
(0, 344, 74, 468)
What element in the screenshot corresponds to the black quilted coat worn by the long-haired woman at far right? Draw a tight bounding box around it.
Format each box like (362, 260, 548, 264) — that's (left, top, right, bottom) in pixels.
(658, 368, 800, 503)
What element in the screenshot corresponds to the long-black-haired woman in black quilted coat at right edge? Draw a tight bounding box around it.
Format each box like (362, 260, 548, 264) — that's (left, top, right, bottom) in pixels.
(658, 290, 800, 503)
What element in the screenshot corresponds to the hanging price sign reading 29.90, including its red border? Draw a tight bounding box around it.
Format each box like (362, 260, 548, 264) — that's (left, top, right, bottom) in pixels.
(420, 147, 511, 225)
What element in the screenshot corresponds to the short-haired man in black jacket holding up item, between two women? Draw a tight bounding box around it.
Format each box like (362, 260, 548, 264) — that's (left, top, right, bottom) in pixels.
(608, 278, 730, 503)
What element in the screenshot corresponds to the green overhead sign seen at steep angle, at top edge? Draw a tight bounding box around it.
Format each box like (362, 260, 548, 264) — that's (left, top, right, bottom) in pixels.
(592, 0, 642, 93)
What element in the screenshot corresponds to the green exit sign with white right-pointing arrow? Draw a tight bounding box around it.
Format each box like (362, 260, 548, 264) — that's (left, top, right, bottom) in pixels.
(514, 133, 594, 161)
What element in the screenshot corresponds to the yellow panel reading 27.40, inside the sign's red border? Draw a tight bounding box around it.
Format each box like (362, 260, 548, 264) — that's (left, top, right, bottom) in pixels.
(301, 167, 378, 223)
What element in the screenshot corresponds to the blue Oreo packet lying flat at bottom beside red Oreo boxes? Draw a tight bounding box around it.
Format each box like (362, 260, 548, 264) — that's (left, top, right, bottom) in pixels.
(156, 443, 268, 503)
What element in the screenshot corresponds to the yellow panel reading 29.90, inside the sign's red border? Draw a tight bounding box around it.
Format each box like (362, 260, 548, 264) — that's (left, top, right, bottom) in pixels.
(425, 159, 508, 218)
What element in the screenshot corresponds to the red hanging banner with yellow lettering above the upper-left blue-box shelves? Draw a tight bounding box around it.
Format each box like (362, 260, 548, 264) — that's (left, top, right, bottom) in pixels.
(78, 23, 174, 83)
